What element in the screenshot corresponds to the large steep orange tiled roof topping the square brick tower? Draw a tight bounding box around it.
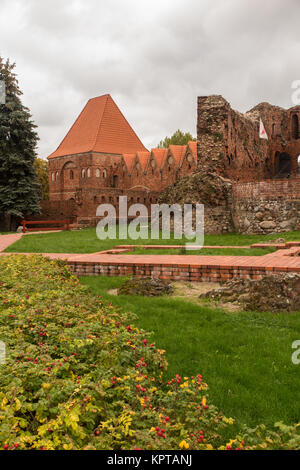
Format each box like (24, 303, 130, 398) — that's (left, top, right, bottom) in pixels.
(48, 95, 147, 158)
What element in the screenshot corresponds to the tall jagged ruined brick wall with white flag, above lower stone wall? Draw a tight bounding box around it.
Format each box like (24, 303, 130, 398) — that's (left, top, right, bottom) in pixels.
(197, 95, 300, 182)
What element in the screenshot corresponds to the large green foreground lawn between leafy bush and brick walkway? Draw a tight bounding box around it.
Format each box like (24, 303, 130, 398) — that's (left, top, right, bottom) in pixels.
(81, 277, 300, 432)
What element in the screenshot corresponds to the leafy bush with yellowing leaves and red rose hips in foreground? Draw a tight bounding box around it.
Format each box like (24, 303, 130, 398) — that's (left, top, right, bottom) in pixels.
(0, 255, 300, 450)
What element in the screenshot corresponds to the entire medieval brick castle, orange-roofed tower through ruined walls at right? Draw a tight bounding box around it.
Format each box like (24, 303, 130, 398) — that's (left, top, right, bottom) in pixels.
(46, 95, 300, 233)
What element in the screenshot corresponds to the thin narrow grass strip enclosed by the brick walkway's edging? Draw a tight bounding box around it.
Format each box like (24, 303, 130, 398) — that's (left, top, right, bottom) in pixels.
(123, 248, 276, 256)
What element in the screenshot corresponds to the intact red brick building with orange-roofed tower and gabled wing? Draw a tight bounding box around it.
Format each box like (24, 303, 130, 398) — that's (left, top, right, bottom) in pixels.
(48, 95, 197, 224)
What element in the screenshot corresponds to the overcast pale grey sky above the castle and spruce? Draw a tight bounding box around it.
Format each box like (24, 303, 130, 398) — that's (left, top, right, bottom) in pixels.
(0, 0, 300, 158)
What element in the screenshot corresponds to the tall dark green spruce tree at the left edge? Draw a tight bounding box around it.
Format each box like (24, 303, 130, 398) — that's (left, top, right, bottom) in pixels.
(0, 57, 41, 230)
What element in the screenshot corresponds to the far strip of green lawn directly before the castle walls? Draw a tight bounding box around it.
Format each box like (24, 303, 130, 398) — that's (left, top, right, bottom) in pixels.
(6, 228, 300, 253)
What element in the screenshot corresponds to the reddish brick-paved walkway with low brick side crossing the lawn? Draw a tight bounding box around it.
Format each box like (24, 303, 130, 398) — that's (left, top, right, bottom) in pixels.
(0, 232, 300, 281)
